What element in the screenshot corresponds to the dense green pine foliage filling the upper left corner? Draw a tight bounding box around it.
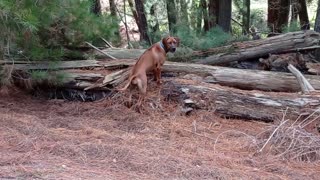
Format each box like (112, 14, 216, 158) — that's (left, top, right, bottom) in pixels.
(0, 0, 118, 60)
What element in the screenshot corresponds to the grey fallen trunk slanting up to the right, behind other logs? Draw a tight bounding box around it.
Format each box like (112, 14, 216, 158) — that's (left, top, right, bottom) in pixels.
(194, 30, 320, 65)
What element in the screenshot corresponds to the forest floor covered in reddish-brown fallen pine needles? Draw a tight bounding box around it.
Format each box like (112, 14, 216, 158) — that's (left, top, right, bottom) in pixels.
(0, 79, 320, 179)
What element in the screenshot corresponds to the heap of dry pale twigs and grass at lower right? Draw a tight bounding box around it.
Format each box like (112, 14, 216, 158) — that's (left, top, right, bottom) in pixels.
(258, 109, 320, 162)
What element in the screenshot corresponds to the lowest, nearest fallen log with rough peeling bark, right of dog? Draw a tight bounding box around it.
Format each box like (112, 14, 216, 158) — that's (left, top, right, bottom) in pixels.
(161, 80, 320, 122)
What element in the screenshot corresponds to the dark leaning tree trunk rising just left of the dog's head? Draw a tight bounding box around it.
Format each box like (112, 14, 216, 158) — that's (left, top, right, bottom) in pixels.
(135, 0, 151, 45)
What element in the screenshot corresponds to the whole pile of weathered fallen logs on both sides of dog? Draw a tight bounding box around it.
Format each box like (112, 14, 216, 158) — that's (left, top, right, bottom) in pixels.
(0, 31, 320, 121)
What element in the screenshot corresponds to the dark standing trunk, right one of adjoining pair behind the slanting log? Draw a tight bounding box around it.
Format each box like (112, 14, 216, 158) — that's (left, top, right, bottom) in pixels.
(218, 0, 232, 32)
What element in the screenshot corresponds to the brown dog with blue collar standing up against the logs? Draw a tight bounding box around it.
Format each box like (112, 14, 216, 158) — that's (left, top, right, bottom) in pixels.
(118, 36, 180, 105)
